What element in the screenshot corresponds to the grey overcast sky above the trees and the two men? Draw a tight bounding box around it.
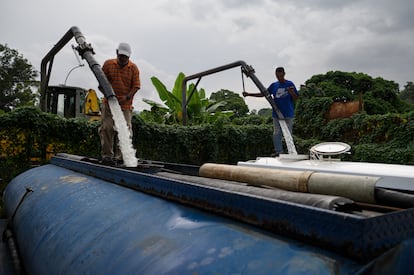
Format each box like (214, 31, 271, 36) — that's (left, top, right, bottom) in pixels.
(0, 0, 414, 110)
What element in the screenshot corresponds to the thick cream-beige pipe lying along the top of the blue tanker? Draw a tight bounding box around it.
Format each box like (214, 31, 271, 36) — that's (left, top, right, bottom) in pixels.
(200, 163, 380, 203)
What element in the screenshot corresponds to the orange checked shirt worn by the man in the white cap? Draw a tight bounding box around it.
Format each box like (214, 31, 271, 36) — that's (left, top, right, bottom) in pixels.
(102, 58, 141, 110)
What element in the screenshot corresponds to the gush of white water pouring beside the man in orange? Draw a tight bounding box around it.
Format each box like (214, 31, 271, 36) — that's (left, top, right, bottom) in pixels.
(108, 97, 138, 167)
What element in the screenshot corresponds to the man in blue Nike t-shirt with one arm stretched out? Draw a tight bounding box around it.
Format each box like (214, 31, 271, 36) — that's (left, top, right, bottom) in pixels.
(243, 67, 299, 156)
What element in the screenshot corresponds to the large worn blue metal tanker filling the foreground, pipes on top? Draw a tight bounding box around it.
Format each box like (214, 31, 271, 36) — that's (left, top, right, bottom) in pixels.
(2, 154, 414, 274)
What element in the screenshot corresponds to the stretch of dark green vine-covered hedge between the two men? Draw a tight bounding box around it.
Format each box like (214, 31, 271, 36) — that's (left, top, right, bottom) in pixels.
(133, 116, 273, 164)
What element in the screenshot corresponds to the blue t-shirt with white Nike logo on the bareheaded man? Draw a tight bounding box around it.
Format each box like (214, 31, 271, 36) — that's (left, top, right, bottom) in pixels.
(267, 80, 299, 118)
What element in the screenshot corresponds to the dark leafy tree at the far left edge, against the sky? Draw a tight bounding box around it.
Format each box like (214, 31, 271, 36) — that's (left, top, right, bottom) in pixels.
(0, 44, 38, 112)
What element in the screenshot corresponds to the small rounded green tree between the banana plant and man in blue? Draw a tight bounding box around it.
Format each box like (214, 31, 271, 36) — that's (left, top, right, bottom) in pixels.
(210, 89, 249, 117)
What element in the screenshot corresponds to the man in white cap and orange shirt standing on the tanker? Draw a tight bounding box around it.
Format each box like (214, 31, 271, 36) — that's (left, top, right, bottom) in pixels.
(99, 43, 141, 164)
